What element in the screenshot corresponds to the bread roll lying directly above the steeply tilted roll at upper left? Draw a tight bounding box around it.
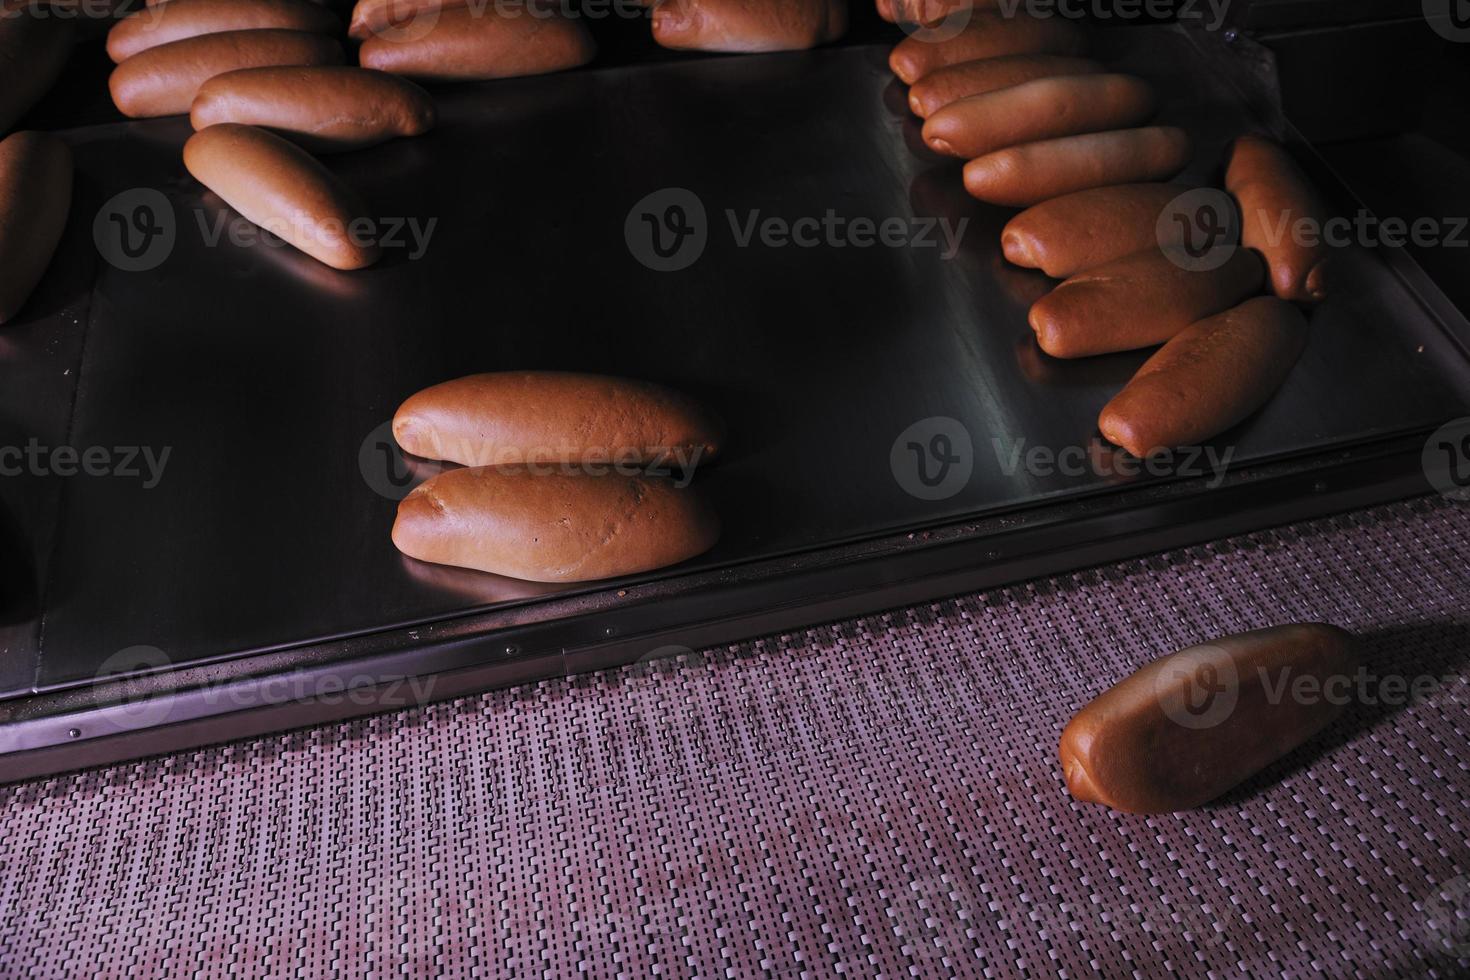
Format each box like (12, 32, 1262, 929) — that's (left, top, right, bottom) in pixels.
(190, 65, 437, 153)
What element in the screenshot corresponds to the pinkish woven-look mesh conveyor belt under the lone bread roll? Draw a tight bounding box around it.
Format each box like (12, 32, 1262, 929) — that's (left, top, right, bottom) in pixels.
(0, 498, 1470, 979)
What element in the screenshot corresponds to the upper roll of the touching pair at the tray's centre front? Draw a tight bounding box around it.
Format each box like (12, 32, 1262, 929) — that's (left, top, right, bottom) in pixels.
(392, 372, 723, 469)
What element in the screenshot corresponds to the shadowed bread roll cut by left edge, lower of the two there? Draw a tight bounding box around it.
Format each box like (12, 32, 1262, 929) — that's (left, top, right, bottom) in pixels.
(0, 131, 72, 323)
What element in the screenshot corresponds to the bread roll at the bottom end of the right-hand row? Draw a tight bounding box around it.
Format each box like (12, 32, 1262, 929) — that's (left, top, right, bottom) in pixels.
(1098, 297, 1307, 457)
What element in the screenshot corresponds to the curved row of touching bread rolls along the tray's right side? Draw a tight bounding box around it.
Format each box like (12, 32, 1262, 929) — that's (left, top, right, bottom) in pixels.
(881, 3, 1326, 455)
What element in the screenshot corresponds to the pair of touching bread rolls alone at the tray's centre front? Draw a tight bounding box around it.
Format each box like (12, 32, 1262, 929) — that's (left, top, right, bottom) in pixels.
(392, 372, 723, 582)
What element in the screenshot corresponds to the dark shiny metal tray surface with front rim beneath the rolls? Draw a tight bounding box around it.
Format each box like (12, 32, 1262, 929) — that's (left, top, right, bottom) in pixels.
(0, 28, 1470, 779)
